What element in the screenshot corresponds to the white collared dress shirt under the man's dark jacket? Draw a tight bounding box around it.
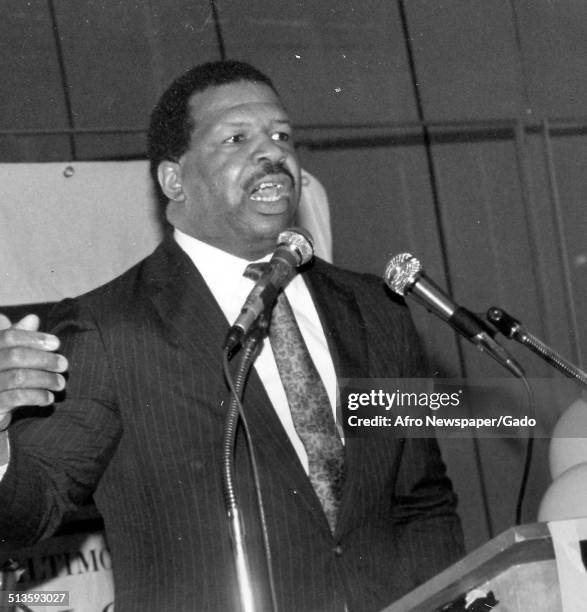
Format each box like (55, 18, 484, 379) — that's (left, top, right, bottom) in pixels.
(174, 229, 337, 472)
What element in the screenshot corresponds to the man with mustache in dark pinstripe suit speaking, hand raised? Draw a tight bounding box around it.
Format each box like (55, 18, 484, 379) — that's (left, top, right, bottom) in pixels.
(0, 62, 462, 612)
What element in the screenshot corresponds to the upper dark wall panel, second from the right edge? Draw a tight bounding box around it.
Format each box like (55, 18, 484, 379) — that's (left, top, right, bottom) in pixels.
(405, 0, 523, 120)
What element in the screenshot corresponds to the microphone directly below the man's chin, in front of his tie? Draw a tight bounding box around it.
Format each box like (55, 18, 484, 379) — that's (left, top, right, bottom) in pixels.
(224, 227, 314, 352)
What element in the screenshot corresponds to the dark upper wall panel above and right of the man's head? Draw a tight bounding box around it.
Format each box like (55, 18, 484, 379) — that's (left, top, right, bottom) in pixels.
(218, 0, 416, 125)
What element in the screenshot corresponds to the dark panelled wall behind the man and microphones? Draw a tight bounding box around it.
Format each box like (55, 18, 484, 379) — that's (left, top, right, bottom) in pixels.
(0, 0, 587, 548)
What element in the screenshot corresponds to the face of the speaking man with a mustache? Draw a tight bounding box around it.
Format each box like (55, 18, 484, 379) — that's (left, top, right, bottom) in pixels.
(160, 81, 300, 259)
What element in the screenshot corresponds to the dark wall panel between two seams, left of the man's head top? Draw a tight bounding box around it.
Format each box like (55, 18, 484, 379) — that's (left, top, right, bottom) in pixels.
(50, 0, 219, 159)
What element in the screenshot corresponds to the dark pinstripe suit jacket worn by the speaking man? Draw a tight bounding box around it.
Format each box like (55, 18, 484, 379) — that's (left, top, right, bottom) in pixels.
(0, 238, 462, 612)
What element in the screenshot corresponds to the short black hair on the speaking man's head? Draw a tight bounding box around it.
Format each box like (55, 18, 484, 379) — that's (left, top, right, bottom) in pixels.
(147, 60, 279, 204)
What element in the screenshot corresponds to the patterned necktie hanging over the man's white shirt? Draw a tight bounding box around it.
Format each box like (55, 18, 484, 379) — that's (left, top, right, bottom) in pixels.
(245, 264, 344, 533)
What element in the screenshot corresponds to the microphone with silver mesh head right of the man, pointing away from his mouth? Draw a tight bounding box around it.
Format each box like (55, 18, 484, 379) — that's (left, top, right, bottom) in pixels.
(384, 253, 525, 378)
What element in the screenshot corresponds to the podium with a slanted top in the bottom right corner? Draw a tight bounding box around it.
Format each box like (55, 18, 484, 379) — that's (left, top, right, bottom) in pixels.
(382, 519, 587, 612)
